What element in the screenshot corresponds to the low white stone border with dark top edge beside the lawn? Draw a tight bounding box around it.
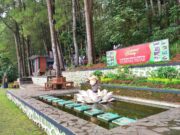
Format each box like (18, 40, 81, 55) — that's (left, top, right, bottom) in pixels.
(7, 91, 75, 135)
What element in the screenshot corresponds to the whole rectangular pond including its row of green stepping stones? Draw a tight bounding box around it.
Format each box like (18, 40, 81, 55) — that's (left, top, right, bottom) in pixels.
(38, 94, 167, 129)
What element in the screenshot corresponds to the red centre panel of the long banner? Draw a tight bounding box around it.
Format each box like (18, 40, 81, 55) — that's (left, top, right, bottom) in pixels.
(116, 43, 151, 65)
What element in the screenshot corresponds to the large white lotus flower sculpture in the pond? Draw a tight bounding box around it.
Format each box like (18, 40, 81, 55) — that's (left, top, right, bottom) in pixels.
(76, 89, 114, 104)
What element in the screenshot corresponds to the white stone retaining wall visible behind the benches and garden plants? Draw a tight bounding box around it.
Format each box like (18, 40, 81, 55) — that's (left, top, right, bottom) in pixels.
(32, 64, 180, 86)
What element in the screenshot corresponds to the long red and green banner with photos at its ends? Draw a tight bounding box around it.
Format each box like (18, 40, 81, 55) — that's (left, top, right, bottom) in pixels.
(106, 39, 169, 66)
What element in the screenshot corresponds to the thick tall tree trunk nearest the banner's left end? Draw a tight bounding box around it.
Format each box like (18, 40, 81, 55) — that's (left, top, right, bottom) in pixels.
(84, 0, 94, 64)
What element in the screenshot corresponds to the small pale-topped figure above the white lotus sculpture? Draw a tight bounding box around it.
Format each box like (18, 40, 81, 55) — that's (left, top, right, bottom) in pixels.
(88, 75, 99, 93)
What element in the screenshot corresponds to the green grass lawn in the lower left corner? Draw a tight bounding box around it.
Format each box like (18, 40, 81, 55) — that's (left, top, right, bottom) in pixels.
(0, 89, 45, 135)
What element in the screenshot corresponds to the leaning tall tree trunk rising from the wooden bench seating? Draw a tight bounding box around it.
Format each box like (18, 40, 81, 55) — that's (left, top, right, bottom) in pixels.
(46, 0, 62, 77)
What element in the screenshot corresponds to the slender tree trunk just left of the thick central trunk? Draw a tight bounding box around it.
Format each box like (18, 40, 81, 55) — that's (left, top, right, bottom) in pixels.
(72, 0, 79, 66)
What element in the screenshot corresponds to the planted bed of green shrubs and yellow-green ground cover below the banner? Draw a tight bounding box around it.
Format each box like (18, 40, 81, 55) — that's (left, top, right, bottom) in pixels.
(94, 66, 180, 89)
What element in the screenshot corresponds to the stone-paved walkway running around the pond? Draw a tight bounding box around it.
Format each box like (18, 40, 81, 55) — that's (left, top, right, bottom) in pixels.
(7, 85, 180, 135)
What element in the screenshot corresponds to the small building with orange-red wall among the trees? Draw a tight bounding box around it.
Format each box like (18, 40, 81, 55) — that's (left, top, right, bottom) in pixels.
(29, 55, 54, 75)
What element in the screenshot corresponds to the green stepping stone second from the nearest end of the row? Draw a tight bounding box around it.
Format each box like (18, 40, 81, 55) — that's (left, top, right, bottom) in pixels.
(97, 113, 121, 122)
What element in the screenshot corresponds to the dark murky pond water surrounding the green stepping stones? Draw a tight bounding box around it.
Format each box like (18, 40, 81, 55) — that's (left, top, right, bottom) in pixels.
(38, 94, 167, 129)
